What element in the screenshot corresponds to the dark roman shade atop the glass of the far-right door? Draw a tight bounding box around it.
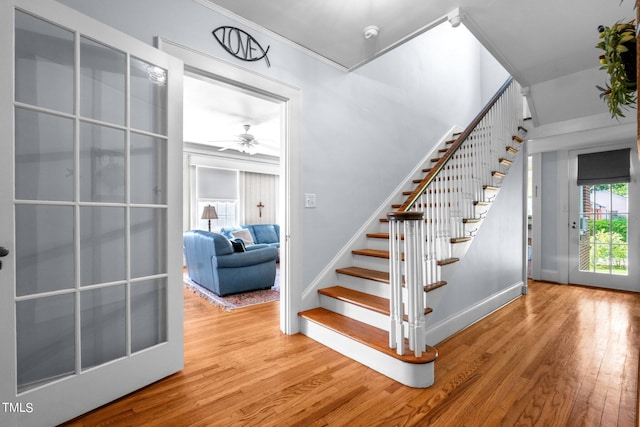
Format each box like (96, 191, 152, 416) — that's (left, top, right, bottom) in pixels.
(578, 148, 631, 185)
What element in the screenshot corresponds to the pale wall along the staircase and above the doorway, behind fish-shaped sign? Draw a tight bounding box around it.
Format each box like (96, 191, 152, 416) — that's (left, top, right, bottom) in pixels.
(59, 0, 507, 288)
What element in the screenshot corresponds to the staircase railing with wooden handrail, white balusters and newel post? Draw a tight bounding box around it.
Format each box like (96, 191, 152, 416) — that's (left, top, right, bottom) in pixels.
(387, 78, 523, 357)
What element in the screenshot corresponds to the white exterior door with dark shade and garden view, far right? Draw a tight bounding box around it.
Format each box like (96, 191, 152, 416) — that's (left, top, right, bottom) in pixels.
(569, 145, 640, 292)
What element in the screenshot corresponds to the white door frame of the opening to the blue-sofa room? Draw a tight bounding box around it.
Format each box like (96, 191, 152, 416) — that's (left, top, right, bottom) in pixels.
(156, 37, 303, 334)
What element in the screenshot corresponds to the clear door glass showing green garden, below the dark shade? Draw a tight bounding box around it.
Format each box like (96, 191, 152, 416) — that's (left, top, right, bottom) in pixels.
(579, 183, 629, 275)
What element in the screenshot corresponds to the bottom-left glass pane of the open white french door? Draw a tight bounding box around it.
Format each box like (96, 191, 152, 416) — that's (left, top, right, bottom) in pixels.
(16, 294, 76, 391)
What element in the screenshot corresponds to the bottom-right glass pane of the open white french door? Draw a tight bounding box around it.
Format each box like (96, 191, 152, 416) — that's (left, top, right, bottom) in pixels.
(131, 278, 167, 352)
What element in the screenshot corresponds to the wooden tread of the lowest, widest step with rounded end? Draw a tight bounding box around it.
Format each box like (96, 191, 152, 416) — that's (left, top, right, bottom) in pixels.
(298, 307, 438, 364)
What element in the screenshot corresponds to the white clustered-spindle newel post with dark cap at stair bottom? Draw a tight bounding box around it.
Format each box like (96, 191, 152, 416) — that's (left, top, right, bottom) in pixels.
(387, 212, 426, 357)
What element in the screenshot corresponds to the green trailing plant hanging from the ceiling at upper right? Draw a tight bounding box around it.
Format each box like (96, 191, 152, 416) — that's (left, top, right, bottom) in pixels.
(596, 20, 637, 117)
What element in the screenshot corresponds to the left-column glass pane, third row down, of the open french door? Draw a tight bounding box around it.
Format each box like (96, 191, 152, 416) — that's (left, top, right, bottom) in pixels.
(15, 205, 75, 296)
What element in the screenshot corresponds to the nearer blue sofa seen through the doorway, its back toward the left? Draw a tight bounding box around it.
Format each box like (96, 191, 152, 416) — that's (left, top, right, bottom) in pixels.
(183, 230, 278, 296)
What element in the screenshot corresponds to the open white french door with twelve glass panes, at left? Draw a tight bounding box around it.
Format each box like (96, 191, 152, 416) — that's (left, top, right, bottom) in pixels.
(0, 0, 183, 426)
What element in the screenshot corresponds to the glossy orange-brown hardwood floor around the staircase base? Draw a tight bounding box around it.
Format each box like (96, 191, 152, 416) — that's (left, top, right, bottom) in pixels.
(68, 282, 640, 427)
